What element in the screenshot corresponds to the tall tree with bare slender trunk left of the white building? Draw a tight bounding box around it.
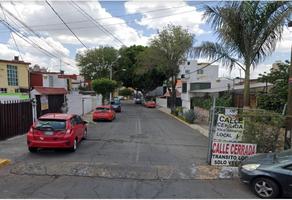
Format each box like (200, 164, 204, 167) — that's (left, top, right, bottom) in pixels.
(139, 25, 194, 113)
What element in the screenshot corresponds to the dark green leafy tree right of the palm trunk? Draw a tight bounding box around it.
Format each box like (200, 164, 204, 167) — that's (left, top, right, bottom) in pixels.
(257, 61, 289, 113)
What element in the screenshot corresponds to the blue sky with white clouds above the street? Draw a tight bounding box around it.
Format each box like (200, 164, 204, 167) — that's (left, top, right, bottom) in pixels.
(0, 0, 292, 78)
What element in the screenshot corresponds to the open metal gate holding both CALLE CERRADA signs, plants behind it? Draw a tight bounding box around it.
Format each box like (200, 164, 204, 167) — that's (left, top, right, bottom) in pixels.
(208, 106, 285, 165)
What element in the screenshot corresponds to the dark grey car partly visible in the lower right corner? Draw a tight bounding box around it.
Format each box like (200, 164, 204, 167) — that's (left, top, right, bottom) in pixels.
(239, 149, 292, 198)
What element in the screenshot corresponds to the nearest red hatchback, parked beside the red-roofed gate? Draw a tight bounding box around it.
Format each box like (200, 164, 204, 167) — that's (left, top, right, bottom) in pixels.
(27, 113, 87, 152)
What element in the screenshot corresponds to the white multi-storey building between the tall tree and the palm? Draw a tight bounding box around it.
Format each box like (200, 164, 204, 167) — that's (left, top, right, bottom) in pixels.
(179, 60, 235, 109)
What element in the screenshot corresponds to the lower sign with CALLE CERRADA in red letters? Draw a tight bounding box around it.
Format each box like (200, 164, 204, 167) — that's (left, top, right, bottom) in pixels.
(211, 141, 257, 166)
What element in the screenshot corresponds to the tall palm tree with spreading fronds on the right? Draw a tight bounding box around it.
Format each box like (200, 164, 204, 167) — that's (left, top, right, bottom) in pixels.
(194, 1, 292, 107)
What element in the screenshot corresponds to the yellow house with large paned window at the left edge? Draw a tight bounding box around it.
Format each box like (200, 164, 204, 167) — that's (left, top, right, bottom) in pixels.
(0, 56, 30, 93)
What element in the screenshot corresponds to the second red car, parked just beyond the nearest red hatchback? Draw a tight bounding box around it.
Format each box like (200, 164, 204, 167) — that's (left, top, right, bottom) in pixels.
(92, 105, 116, 121)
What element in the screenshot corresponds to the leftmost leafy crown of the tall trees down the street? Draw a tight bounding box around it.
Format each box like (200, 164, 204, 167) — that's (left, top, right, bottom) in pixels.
(76, 47, 118, 80)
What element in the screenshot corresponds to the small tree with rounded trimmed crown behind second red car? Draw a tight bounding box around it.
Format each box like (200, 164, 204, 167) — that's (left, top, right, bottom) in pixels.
(92, 78, 118, 105)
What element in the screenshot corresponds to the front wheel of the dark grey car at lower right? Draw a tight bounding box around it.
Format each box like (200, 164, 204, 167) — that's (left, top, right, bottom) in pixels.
(252, 177, 280, 199)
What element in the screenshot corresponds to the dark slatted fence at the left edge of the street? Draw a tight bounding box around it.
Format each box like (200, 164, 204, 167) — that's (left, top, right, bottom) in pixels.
(0, 100, 33, 140)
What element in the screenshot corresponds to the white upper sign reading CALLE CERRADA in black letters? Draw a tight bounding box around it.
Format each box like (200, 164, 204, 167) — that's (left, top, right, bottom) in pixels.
(213, 114, 244, 142)
